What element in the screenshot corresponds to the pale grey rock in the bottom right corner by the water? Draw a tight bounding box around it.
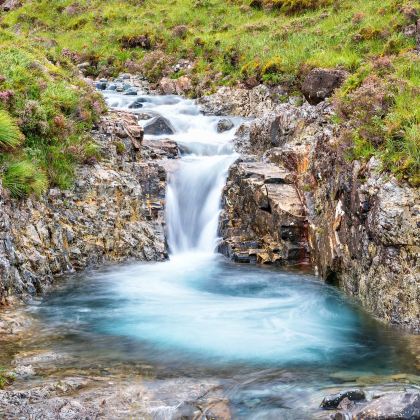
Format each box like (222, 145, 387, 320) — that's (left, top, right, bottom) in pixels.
(352, 392, 420, 420)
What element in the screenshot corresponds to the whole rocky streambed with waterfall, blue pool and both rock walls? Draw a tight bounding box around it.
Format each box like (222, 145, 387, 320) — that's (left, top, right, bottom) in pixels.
(0, 77, 420, 419)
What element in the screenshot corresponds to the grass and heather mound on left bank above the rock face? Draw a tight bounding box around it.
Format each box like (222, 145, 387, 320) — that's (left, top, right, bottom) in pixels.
(0, 30, 103, 198)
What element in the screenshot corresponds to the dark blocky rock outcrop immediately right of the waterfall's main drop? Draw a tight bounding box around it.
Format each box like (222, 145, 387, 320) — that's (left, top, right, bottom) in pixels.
(219, 160, 308, 264)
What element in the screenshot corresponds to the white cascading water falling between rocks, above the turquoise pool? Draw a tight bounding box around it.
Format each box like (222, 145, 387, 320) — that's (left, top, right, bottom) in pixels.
(106, 93, 240, 254)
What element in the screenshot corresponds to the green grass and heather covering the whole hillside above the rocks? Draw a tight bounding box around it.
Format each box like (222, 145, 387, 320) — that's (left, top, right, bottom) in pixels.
(0, 0, 420, 194)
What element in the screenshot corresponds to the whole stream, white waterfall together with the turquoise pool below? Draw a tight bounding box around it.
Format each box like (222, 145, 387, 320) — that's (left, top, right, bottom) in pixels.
(1, 88, 418, 420)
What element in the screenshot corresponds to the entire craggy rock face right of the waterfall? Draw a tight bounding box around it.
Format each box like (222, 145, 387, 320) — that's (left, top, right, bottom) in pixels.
(208, 87, 420, 331)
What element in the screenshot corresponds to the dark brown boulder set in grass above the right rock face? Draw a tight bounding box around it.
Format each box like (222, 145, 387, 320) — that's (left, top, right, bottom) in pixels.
(302, 68, 348, 105)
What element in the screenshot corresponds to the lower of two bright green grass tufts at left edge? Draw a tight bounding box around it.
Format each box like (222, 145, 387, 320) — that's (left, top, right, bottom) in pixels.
(2, 160, 48, 198)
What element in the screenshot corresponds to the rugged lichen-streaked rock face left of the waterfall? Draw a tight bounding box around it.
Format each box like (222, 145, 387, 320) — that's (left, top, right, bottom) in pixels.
(0, 113, 177, 301)
